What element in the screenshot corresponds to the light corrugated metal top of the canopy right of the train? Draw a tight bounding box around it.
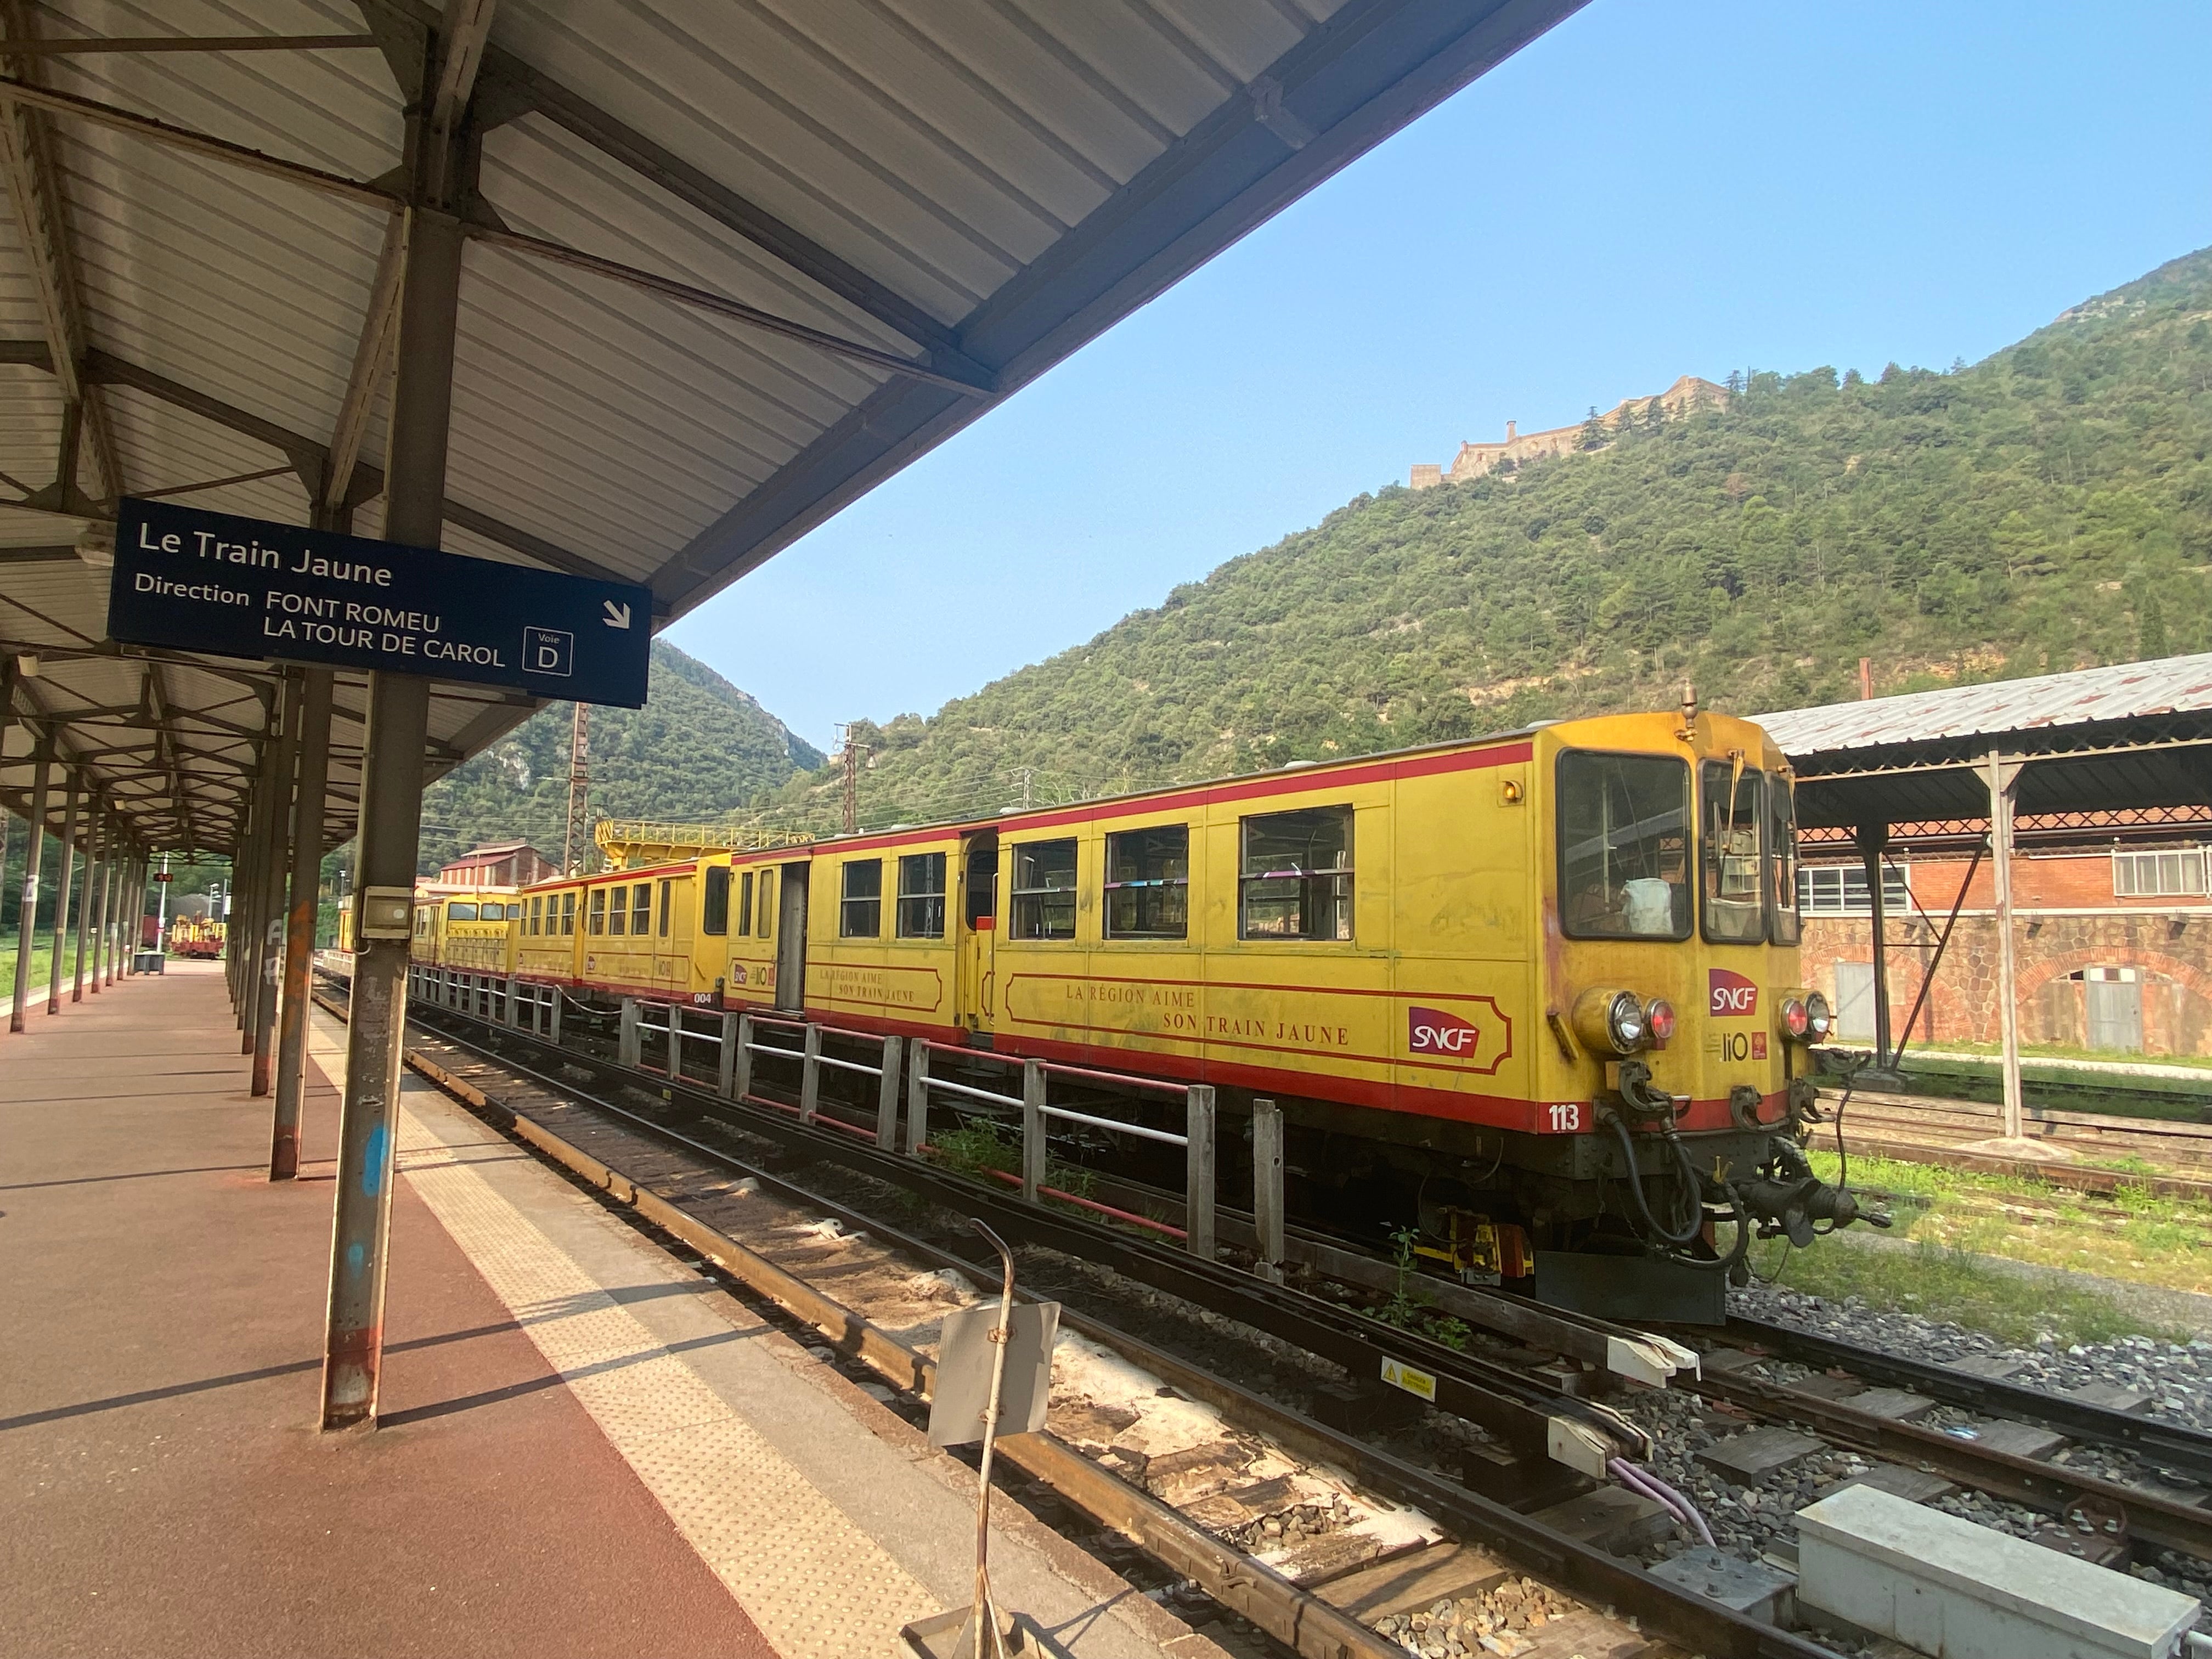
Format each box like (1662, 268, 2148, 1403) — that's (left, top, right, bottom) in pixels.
(1758, 652, 2212, 759)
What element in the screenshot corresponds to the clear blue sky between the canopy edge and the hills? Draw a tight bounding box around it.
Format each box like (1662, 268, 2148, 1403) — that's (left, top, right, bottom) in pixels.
(668, 0, 2212, 746)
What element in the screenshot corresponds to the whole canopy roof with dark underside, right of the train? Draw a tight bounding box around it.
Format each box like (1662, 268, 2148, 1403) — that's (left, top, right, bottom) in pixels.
(1758, 654, 2212, 834)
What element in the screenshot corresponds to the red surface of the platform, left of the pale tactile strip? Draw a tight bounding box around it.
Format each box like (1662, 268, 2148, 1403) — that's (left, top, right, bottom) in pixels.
(0, 962, 770, 1659)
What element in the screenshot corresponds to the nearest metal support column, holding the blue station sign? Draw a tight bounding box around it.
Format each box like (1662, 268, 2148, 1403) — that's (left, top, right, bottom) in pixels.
(323, 206, 462, 1429)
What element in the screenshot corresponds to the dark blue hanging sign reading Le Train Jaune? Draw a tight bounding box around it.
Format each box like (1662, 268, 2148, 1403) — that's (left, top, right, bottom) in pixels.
(109, 495, 652, 708)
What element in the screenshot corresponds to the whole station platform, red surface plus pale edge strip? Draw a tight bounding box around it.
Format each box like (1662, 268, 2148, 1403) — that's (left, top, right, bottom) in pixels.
(0, 962, 1219, 1659)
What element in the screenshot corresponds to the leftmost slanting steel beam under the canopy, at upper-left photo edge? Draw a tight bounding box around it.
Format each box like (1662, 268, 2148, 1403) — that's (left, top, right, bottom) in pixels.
(0, 0, 124, 513)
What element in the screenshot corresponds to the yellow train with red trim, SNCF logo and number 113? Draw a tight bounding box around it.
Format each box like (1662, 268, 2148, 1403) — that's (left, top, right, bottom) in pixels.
(418, 706, 1856, 1296)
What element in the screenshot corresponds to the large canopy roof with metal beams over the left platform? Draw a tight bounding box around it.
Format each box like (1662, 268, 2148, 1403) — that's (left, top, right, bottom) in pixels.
(0, 0, 1579, 849)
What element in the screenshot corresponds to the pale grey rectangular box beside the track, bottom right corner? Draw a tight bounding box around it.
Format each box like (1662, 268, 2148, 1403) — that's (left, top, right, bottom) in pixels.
(1796, 1487, 2199, 1659)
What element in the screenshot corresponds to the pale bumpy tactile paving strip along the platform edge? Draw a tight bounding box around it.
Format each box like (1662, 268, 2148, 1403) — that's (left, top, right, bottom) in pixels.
(400, 1104, 938, 1659)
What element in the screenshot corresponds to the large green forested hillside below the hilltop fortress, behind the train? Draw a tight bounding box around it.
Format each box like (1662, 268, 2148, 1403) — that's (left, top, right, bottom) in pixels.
(772, 250, 2212, 825)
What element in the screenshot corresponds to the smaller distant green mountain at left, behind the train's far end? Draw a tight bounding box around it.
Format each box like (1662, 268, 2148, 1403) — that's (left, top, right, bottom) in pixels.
(420, 641, 823, 874)
